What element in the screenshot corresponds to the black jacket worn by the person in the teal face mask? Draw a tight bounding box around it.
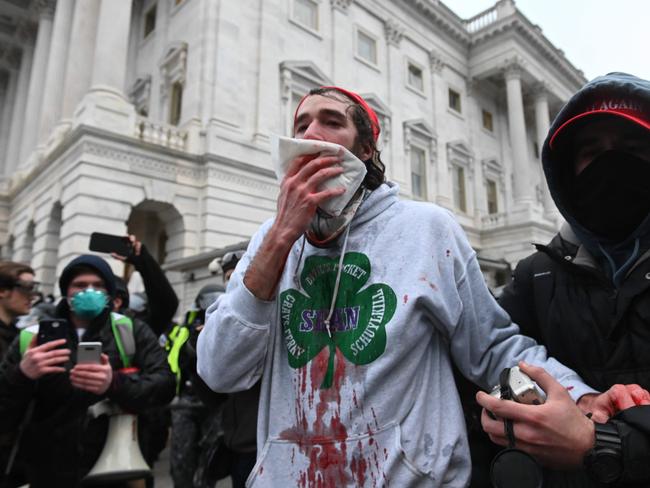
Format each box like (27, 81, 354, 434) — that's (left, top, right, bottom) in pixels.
(0, 263, 175, 488)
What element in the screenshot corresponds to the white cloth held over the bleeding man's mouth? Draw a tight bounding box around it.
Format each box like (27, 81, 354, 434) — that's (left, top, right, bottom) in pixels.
(271, 135, 367, 217)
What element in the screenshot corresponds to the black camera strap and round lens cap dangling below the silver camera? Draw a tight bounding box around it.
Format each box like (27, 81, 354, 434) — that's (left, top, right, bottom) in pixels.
(490, 368, 544, 488)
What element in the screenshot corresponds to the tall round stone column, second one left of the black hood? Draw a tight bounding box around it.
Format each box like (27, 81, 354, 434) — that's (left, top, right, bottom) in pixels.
(505, 61, 535, 206)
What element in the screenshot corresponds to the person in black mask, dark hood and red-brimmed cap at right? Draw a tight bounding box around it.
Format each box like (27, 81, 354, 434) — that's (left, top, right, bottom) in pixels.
(478, 73, 650, 487)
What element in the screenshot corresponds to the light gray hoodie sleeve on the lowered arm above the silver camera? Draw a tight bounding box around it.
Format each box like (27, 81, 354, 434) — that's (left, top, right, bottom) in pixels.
(438, 216, 595, 400)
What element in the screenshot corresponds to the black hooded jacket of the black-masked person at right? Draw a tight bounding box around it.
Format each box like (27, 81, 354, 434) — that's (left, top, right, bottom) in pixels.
(499, 73, 650, 487)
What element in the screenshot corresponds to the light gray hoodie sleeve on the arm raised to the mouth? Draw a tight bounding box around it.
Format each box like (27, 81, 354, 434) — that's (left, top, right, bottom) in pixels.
(197, 221, 275, 393)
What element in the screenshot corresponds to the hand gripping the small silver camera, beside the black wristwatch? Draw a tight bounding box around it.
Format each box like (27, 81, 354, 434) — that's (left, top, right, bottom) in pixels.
(476, 362, 595, 468)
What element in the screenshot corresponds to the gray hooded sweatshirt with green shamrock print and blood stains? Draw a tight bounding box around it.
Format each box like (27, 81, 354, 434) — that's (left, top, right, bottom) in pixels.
(198, 184, 593, 488)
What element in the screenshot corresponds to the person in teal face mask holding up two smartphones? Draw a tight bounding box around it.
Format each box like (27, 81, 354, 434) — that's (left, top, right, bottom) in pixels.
(0, 255, 174, 488)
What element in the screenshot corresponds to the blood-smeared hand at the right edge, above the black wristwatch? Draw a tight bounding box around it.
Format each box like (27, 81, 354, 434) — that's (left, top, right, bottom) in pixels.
(578, 384, 650, 424)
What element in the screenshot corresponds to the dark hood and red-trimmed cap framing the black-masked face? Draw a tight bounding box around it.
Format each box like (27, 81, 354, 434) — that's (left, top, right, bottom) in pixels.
(542, 73, 650, 280)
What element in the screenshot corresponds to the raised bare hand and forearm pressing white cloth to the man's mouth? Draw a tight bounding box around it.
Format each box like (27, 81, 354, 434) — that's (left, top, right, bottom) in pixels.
(244, 151, 345, 300)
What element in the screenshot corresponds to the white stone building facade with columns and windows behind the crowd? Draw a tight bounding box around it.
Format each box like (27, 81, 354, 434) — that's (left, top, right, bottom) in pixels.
(0, 0, 586, 310)
